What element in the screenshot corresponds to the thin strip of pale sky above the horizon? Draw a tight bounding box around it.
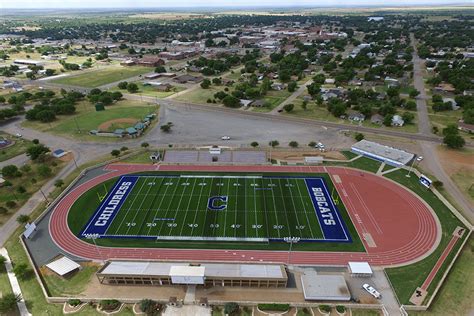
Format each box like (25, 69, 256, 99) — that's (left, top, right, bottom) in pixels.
(0, 0, 472, 9)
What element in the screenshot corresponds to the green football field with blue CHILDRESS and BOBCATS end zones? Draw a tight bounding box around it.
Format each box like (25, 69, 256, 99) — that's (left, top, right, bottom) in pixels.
(80, 174, 352, 242)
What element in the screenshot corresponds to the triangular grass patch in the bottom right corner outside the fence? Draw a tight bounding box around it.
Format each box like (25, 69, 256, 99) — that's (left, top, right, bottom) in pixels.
(410, 237, 474, 316)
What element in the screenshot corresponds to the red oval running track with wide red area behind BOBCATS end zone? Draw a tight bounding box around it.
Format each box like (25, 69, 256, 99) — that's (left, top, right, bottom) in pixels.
(49, 164, 441, 266)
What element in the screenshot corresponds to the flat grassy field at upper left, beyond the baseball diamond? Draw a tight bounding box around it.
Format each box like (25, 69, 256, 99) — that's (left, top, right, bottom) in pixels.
(52, 66, 153, 88)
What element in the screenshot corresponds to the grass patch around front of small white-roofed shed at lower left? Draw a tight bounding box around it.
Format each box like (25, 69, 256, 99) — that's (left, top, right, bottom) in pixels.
(42, 264, 99, 296)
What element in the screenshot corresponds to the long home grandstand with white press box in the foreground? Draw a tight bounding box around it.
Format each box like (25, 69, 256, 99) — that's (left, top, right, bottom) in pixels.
(97, 261, 288, 288)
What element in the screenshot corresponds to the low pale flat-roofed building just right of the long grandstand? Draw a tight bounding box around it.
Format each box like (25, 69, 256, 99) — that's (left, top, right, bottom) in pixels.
(301, 272, 351, 301)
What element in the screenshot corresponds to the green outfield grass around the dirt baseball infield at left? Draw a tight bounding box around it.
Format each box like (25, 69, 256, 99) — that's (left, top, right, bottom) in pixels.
(22, 100, 159, 141)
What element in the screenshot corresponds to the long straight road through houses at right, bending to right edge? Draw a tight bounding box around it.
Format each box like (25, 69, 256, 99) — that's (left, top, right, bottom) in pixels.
(410, 34, 474, 223)
